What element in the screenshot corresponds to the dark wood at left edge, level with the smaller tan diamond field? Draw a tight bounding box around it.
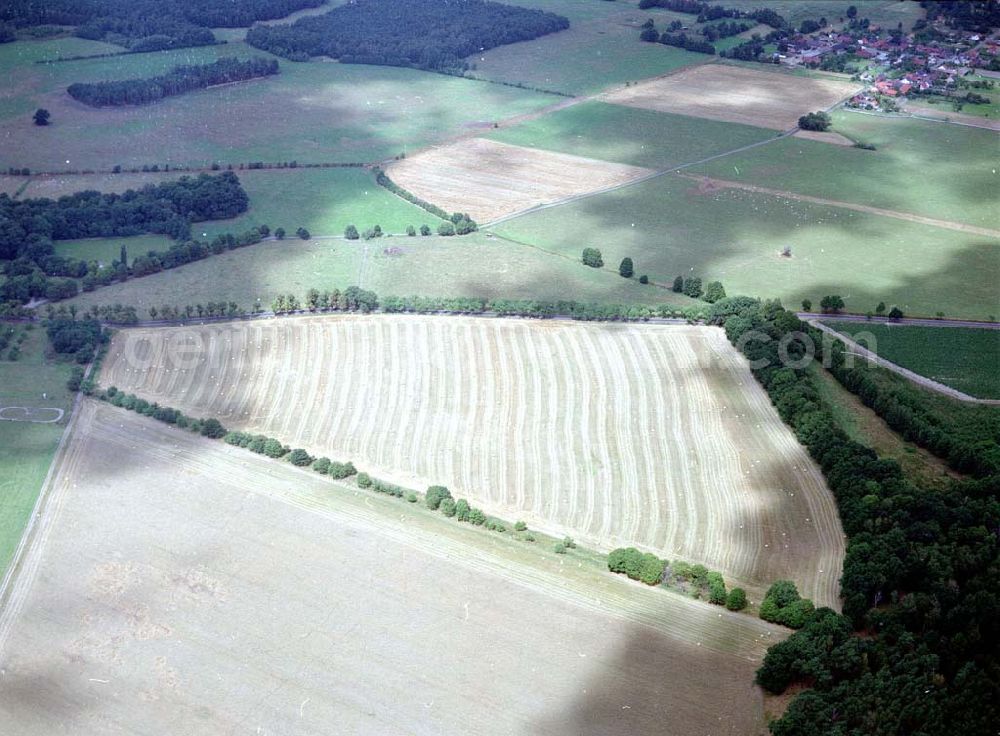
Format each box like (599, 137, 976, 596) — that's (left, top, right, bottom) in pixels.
(0, 172, 249, 303)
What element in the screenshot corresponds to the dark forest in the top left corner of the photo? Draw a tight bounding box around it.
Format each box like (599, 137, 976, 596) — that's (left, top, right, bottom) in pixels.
(0, 0, 325, 52)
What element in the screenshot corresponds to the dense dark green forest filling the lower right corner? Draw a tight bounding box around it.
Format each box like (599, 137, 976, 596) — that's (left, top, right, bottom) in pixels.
(713, 297, 1000, 736)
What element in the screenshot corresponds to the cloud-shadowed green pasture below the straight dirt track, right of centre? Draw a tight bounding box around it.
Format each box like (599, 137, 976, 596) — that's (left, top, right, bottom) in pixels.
(495, 174, 1000, 319)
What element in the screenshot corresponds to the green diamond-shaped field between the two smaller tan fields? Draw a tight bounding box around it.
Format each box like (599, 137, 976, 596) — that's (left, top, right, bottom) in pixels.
(488, 101, 775, 169)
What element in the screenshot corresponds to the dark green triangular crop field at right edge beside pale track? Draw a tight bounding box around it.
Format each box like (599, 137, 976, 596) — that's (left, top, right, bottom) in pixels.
(829, 322, 1000, 399)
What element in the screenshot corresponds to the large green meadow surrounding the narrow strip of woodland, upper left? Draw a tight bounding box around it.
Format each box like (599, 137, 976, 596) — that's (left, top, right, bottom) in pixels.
(0, 39, 558, 171)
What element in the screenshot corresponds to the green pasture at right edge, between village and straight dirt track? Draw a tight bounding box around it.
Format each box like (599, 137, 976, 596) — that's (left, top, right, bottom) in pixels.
(692, 111, 1000, 228)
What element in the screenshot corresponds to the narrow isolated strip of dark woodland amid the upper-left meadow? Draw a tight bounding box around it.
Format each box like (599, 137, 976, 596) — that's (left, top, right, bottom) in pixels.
(66, 57, 278, 107)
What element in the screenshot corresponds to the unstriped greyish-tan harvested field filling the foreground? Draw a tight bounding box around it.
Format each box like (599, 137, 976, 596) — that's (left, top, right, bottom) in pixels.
(0, 401, 781, 736)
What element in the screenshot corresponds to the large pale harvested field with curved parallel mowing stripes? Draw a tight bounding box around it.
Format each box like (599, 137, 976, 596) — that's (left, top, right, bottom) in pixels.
(102, 316, 843, 606)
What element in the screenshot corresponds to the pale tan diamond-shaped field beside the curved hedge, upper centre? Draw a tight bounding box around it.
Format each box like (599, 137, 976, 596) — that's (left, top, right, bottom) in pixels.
(388, 138, 652, 222)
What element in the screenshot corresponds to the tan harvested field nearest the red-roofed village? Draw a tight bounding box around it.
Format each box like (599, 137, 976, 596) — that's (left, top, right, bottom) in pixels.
(604, 64, 860, 130)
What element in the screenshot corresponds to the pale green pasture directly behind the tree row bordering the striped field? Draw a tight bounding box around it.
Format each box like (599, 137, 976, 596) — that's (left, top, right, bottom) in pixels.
(62, 233, 694, 317)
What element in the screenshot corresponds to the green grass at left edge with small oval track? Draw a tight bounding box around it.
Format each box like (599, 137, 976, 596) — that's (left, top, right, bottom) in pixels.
(0, 322, 73, 574)
